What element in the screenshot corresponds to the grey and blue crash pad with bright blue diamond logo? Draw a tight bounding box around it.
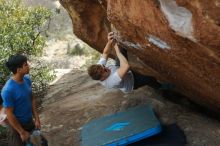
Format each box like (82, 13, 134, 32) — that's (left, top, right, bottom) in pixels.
(81, 106, 161, 146)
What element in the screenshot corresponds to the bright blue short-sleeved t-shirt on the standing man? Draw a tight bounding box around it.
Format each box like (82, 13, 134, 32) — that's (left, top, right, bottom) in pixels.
(1, 76, 32, 124)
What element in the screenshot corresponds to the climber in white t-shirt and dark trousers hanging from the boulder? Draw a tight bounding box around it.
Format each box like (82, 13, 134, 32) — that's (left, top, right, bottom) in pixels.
(88, 32, 173, 93)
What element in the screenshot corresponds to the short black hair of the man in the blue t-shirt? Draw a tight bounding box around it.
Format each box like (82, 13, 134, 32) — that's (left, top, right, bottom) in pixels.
(5, 54, 27, 74)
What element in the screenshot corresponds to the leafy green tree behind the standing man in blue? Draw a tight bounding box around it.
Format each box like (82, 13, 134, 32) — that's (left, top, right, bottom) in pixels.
(0, 0, 53, 95)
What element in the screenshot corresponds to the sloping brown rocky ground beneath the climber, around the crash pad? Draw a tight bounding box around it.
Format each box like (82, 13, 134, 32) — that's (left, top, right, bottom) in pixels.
(40, 70, 220, 146)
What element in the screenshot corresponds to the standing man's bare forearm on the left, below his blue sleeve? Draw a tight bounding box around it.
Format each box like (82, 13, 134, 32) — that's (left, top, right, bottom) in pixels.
(5, 107, 30, 141)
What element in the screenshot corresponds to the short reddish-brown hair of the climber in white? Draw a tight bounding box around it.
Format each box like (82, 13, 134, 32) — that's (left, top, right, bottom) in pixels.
(87, 64, 103, 80)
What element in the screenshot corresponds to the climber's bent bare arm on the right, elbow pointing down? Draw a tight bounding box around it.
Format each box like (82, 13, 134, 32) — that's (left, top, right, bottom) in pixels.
(114, 44, 130, 79)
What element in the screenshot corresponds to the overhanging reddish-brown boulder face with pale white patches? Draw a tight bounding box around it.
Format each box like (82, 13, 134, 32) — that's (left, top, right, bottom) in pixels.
(60, 0, 220, 112)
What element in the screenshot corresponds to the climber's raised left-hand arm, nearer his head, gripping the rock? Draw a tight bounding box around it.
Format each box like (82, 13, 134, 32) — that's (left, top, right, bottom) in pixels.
(102, 32, 114, 59)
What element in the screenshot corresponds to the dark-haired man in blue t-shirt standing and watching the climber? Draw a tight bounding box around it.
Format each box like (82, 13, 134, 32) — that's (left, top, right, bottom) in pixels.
(1, 54, 40, 146)
